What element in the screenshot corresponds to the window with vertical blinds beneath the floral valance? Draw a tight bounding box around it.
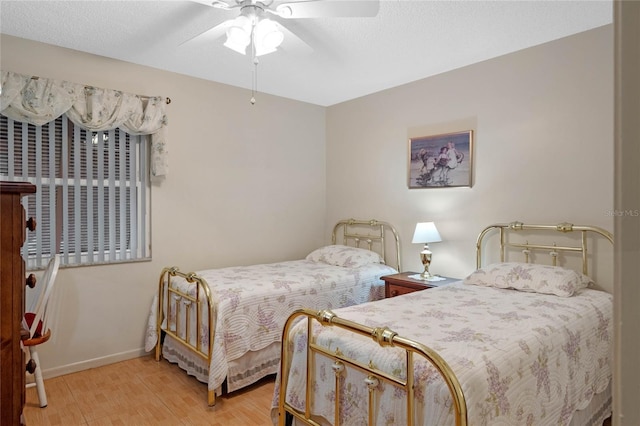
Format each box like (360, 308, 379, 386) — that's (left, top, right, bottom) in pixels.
(0, 115, 151, 269)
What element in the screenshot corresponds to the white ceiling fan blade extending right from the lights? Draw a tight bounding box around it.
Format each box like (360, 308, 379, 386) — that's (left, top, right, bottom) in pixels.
(276, 0, 380, 19)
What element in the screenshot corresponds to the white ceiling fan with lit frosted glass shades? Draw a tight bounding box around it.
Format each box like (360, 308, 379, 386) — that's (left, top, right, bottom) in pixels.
(186, 0, 380, 57)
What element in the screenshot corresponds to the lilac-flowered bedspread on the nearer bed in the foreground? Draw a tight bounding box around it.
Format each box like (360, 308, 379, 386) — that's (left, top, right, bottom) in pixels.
(272, 282, 613, 426)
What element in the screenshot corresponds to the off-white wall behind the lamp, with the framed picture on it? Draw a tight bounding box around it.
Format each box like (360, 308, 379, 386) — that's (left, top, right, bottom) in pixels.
(327, 26, 613, 289)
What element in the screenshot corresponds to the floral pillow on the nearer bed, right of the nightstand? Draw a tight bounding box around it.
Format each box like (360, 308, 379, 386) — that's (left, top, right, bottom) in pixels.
(464, 262, 592, 297)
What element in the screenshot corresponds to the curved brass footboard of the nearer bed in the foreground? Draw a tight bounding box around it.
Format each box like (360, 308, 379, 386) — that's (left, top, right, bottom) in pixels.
(278, 309, 467, 426)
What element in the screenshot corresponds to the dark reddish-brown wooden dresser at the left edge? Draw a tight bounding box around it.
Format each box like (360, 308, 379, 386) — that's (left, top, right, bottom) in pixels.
(0, 182, 36, 426)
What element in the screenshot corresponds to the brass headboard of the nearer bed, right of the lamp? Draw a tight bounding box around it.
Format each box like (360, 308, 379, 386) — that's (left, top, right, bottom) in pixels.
(476, 222, 613, 288)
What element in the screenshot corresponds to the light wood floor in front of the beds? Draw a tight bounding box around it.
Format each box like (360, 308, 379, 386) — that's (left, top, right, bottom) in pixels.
(24, 356, 275, 426)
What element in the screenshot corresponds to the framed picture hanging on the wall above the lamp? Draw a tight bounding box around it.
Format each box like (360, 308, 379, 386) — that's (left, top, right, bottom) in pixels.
(409, 130, 473, 189)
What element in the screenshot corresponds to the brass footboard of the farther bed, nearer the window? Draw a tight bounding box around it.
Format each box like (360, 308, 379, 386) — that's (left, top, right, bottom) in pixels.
(155, 267, 217, 406)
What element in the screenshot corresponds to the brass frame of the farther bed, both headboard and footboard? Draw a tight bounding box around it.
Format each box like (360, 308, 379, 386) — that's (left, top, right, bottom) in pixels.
(155, 219, 402, 406)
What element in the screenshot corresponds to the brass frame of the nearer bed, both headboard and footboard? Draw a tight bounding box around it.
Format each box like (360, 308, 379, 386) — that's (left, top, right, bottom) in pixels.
(278, 222, 613, 426)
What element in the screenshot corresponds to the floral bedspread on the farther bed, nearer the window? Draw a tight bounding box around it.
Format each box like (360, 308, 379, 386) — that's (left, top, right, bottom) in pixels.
(145, 260, 396, 391)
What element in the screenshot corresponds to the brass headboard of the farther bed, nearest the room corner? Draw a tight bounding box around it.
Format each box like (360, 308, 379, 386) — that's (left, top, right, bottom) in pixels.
(331, 219, 402, 272)
